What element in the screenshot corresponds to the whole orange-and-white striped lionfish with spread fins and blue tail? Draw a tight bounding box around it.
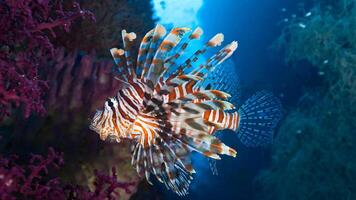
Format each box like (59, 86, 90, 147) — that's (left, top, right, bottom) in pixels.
(90, 25, 281, 195)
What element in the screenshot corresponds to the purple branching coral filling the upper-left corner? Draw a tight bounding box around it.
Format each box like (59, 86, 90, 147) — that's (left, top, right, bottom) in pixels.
(0, 0, 93, 121)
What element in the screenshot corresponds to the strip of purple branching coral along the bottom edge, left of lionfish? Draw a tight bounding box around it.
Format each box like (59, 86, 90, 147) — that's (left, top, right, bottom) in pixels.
(0, 148, 135, 200)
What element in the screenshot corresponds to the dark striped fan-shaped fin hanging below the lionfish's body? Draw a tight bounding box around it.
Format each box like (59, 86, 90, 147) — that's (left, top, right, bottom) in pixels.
(132, 133, 192, 195)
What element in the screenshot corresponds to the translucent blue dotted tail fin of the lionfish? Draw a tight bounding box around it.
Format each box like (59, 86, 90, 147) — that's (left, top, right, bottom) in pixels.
(238, 91, 282, 147)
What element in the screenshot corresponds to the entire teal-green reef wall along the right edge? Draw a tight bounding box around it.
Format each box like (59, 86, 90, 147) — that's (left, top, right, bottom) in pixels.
(258, 0, 356, 200)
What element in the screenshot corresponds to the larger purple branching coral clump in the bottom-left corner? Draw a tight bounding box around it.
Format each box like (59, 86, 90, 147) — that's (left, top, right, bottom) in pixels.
(0, 148, 65, 200)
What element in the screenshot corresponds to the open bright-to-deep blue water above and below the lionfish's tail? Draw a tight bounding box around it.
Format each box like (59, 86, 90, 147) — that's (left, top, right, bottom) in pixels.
(153, 0, 313, 200)
